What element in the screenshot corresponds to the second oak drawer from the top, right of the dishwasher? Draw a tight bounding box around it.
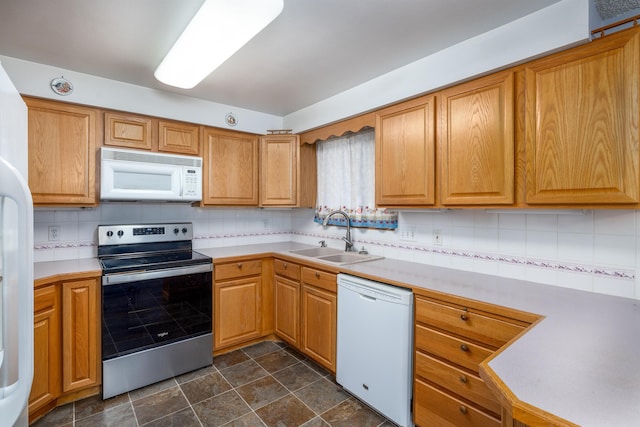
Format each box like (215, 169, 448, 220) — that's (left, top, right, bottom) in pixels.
(416, 325, 493, 374)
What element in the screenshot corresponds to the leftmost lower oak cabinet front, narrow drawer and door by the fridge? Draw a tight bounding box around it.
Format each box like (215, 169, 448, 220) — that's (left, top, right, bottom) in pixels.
(29, 285, 61, 414)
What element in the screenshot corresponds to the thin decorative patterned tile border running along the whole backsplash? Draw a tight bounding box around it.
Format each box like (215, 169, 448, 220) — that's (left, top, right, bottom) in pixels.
(34, 231, 636, 280)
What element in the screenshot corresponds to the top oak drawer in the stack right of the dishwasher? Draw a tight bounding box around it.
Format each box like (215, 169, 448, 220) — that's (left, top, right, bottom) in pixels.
(416, 298, 524, 348)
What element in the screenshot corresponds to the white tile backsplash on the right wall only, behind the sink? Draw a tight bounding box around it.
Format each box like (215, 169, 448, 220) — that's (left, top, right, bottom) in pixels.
(292, 209, 640, 299)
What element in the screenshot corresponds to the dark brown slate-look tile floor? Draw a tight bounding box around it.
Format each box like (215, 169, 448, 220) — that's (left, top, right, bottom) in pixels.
(33, 341, 394, 427)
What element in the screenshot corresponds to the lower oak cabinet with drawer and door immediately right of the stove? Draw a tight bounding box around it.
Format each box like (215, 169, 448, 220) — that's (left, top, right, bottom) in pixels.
(213, 259, 262, 351)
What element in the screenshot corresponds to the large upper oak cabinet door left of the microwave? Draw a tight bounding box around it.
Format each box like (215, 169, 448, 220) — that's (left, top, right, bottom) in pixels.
(25, 98, 99, 206)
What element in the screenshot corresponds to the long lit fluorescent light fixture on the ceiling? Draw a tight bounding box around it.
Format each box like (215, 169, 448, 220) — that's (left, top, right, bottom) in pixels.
(154, 0, 284, 89)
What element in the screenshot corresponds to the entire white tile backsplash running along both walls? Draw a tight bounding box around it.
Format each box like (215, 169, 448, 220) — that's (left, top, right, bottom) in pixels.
(34, 203, 640, 299)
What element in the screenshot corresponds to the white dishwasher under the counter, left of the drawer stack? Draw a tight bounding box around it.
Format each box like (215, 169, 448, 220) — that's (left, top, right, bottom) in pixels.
(336, 274, 413, 427)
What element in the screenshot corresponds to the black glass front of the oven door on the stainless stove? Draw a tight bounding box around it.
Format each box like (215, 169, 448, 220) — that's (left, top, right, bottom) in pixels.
(102, 272, 212, 360)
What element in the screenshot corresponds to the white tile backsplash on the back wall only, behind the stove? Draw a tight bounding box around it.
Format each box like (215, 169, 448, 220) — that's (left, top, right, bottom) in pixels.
(34, 203, 291, 262)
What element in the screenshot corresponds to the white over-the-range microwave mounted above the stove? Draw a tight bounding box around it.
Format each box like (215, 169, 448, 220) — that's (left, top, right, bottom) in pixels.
(100, 147, 202, 202)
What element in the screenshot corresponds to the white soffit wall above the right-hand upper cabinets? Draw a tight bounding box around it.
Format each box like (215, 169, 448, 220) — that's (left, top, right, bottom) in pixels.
(283, 0, 590, 132)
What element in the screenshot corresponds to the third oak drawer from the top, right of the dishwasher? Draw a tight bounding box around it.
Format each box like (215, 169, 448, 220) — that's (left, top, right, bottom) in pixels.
(415, 351, 501, 414)
